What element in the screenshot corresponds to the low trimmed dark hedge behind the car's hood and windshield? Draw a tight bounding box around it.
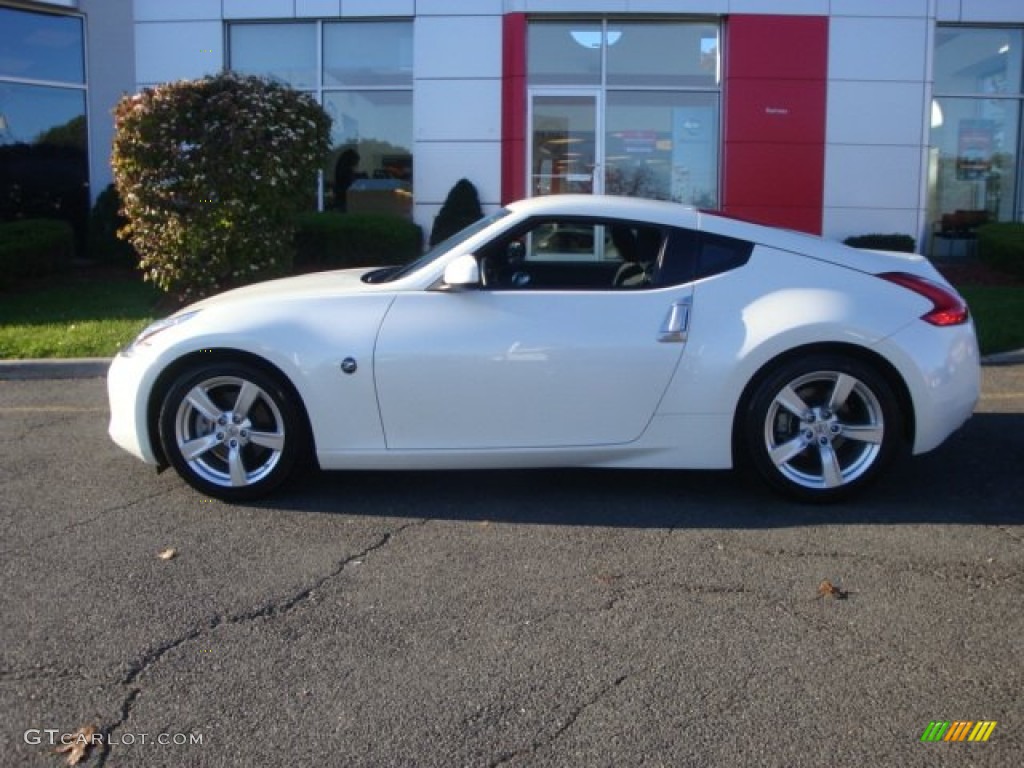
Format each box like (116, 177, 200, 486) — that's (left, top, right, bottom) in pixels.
(295, 212, 423, 271)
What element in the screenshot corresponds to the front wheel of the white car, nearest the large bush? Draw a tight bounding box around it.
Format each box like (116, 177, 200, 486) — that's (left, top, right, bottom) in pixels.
(159, 360, 309, 502)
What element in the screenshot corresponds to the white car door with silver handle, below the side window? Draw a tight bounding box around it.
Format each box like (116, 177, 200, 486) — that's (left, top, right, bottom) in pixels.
(374, 217, 692, 451)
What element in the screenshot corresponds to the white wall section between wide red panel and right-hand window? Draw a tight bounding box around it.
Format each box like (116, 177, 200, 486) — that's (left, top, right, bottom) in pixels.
(822, 0, 934, 245)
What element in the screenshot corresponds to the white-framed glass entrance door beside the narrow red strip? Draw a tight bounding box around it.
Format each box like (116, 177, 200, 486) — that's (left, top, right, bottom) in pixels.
(529, 90, 604, 197)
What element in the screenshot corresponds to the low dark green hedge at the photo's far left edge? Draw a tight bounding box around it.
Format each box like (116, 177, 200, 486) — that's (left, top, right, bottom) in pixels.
(0, 219, 75, 288)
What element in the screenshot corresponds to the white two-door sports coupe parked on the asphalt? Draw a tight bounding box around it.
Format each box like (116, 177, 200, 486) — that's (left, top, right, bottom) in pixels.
(109, 196, 980, 501)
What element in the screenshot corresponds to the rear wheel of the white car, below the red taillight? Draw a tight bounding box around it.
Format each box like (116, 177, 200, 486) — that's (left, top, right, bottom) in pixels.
(738, 354, 904, 502)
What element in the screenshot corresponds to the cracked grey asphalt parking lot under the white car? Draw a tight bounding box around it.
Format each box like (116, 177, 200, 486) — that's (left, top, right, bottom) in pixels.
(0, 366, 1024, 768)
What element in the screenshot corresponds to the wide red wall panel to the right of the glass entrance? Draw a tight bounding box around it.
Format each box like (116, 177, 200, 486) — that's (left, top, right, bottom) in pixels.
(722, 15, 828, 233)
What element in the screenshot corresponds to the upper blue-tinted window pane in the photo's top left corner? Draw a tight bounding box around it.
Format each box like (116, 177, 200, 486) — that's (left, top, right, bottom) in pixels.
(0, 8, 85, 85)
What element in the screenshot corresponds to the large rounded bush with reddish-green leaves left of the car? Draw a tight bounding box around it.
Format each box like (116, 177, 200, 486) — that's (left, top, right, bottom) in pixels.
(112, 73, 331, 301)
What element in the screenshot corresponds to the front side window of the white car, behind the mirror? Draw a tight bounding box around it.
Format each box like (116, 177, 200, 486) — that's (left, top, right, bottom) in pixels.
(477, 217, 666, 291)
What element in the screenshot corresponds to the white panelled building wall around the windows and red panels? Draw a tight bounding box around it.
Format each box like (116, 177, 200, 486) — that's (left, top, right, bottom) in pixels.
(121, 0, 1024, 246)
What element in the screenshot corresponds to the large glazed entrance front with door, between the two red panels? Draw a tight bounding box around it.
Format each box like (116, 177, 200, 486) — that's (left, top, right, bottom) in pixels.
(527, 18, 721, 208)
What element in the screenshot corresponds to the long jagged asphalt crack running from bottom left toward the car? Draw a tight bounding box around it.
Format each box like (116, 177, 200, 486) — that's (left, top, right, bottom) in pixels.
(97, 519, 429, 766)
